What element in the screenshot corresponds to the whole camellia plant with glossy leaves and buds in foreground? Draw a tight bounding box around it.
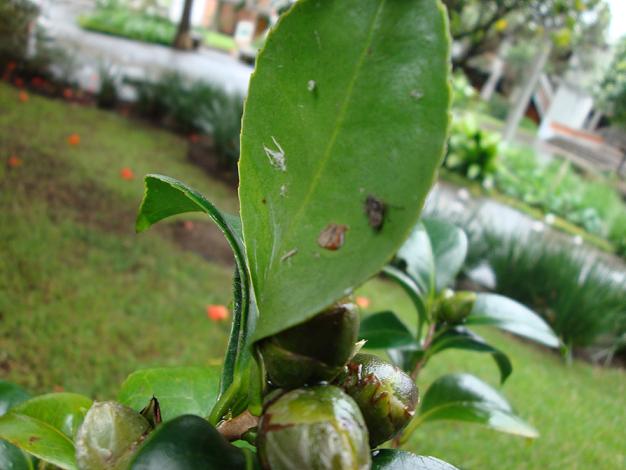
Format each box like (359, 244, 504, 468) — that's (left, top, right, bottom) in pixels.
(0, 0, 553, 470)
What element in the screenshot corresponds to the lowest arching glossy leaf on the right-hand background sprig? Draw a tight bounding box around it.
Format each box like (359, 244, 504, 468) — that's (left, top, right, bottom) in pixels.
(403, 374, 539, 441)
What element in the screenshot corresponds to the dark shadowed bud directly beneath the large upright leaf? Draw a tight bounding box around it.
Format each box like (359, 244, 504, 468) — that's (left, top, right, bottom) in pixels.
(259, 304, 359, 388)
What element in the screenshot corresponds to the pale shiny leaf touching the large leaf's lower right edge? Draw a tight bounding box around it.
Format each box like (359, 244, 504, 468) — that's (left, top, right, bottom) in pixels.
(396, 222, 435, 297)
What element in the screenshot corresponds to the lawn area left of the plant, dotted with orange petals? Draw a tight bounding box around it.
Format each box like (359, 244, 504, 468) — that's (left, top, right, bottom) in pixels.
(0, 85, 236, 397)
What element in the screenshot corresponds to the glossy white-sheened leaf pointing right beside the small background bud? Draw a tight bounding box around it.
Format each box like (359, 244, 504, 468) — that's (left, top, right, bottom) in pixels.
(466, 293, 561, 348)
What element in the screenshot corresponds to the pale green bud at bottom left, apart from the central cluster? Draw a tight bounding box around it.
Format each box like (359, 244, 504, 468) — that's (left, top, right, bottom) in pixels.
(76, 401, 150, 470)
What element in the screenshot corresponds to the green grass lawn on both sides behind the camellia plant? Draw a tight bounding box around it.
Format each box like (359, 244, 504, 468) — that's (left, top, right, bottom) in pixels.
(0, 85, 626, 469)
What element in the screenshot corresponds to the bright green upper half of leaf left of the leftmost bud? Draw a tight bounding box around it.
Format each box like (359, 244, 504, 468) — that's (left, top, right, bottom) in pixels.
(12, 393, 93, 440)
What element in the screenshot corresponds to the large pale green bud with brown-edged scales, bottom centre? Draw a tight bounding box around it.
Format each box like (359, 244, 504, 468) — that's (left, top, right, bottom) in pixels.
(257, 385, 371, 470)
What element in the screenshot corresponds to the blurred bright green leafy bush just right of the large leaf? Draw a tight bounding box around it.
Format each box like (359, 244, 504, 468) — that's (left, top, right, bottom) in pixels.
(444, 116, 500, 187)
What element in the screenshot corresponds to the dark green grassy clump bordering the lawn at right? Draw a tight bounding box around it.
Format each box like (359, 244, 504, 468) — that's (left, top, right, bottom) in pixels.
(469, 229, 626, 356)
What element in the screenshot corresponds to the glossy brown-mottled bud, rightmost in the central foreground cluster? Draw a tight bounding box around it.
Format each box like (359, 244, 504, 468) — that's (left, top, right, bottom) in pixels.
(337, 354, 418, 447)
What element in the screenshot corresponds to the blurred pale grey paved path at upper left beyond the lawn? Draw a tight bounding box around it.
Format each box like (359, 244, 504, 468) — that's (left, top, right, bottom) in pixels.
(43, 0, 253, 95)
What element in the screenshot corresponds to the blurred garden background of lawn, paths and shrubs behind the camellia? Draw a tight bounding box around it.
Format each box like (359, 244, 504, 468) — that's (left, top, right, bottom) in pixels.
(0, 0, 626, 469)
